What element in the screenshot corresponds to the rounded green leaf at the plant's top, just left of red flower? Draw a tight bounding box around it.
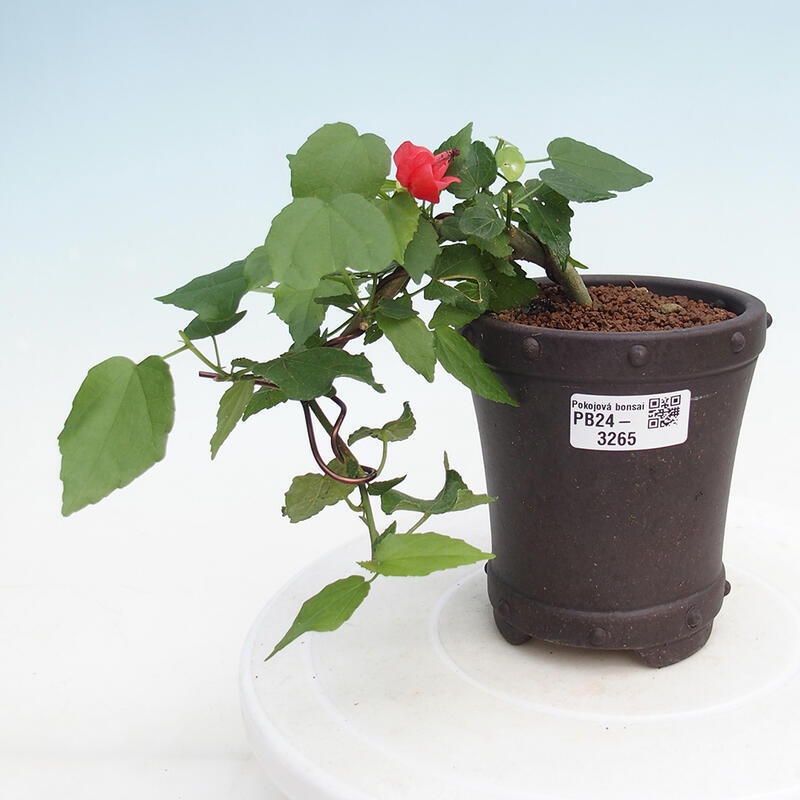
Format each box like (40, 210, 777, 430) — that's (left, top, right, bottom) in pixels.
(287, 122, 391, 200)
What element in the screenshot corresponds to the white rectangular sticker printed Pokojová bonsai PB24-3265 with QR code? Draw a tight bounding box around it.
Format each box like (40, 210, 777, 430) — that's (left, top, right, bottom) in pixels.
(569, 389, 692, 450)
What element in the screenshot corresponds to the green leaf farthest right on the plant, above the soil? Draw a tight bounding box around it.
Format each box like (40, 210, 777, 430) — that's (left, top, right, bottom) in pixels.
(540, 137, 653, 201)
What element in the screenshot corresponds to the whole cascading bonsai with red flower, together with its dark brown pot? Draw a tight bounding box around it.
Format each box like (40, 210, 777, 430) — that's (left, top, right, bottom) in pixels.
(59, 123, 766, 665)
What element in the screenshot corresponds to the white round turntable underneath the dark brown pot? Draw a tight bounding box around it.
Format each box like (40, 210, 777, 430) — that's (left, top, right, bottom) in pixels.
(241, 507, 800, 800)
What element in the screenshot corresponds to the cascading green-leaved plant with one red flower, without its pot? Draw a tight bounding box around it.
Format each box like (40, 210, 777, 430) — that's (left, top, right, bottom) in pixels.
(59, 123, 651, 656)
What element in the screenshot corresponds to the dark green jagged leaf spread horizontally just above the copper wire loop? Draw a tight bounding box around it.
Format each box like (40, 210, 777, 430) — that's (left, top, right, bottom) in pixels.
(249, 347, 383, 400)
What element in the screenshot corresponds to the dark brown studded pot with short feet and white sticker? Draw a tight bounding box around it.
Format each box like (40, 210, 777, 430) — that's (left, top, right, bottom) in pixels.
(464, 276, 768, 667)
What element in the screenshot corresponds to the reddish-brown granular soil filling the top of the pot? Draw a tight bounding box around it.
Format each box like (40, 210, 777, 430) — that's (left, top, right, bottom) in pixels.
(497, 285, 736, 332)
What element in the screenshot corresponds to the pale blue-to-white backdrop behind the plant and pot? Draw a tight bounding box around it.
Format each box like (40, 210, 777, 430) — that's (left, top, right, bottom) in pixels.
(0, 0, 800, 797)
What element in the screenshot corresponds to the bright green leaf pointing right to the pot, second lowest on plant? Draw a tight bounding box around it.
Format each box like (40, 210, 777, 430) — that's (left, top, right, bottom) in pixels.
(358, 533, 494, 576)
